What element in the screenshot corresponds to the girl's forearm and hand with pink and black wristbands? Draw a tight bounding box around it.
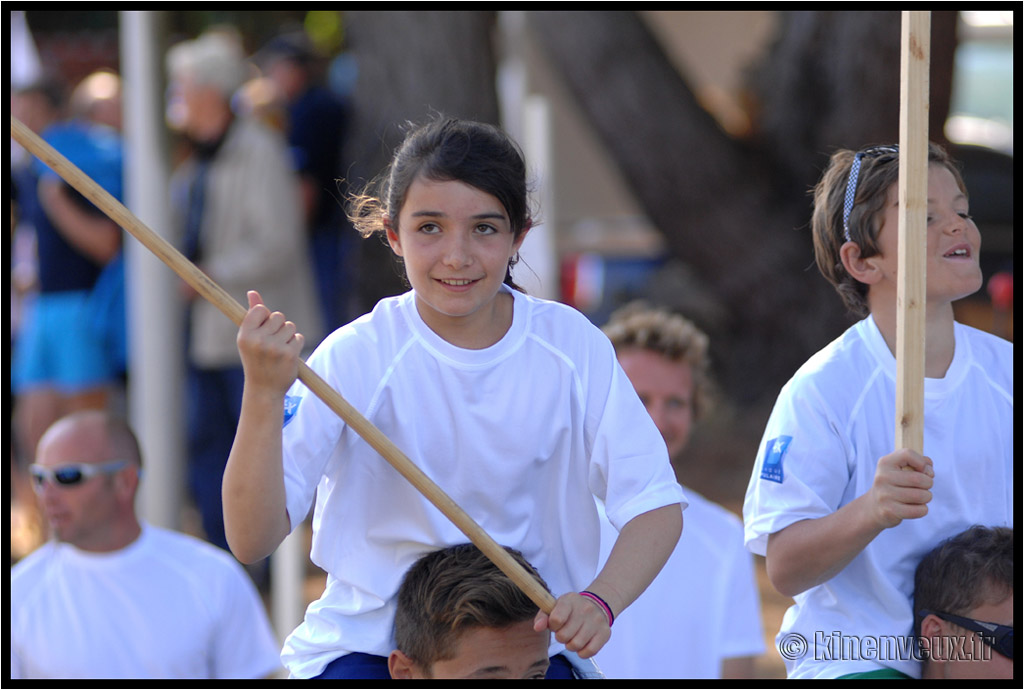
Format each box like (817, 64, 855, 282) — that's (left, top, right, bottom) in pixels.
(535, 504, 683, 658)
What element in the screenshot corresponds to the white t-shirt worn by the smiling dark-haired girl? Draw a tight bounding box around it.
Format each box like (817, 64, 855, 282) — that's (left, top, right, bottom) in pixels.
(282, 292, 683, 678)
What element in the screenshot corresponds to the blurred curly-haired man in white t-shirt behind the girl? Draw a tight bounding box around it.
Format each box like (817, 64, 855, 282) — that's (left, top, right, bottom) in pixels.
(597, 302, 764, 679)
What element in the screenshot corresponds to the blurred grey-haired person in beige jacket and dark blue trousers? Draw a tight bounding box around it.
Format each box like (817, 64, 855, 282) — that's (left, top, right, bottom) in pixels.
(167, 30, 322, 561)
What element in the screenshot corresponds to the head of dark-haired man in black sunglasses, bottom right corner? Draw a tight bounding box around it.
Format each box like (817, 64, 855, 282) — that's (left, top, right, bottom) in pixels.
(913, 525, 1014, 680)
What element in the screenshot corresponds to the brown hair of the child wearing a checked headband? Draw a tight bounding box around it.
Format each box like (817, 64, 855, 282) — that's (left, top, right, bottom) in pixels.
(811, 143, 967, 316)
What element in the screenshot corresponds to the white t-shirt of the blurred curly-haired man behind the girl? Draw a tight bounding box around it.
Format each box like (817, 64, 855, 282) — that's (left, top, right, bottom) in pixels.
(595, 486, 765, 679)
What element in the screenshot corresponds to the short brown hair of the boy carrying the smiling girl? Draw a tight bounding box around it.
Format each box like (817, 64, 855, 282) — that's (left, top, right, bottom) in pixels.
(394, 544, 549, 670)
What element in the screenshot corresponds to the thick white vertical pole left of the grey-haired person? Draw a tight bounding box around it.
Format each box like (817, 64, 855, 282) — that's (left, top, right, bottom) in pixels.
(120, 11, 184, 528)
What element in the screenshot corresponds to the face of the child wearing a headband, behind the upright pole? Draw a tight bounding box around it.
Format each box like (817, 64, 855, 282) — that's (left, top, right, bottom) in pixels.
(871, 164, 982, 303)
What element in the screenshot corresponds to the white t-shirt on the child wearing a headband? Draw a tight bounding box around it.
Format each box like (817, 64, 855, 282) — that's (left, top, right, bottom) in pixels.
(743, 317, 1014, 678)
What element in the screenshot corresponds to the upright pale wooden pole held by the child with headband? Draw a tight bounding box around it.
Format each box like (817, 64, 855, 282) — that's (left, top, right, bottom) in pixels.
(896, 11, 931, 452)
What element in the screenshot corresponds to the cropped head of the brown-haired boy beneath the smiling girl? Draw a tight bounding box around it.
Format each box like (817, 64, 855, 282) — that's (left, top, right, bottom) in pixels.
(388, 544, 551, 679)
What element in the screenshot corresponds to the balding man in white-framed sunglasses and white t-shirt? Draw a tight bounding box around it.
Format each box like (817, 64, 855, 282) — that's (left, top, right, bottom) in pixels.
(10, 411, 281, 679)
